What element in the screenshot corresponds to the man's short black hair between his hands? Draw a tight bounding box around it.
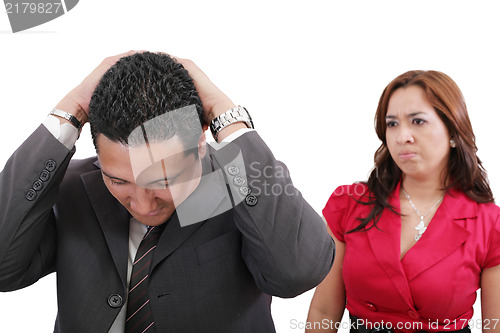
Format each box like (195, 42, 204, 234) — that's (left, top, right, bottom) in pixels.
(89, 52, 205, 153)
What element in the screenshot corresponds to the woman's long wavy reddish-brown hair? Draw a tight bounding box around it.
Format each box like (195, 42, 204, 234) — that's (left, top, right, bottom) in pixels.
(349, 71, 494, 232)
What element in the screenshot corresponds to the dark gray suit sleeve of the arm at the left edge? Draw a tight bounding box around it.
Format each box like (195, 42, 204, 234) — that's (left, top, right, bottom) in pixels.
(0, 125, 74, 291)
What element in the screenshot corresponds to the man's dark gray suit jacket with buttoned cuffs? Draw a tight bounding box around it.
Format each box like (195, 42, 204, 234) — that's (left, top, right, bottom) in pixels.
(0, 126, 334, 333)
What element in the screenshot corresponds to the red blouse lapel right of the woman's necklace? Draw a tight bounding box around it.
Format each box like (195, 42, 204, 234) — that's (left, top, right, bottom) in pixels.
(402, 190, 477, 281)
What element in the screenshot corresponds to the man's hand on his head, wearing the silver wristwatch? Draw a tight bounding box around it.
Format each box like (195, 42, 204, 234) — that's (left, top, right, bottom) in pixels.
(174, 57, 247, 142)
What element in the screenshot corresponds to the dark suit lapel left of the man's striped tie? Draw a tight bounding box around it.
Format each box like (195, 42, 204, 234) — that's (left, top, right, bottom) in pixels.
(81, 166, 130, 286)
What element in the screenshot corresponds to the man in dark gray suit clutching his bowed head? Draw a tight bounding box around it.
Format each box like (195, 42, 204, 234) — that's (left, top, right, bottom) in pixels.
(0, 51, 334, 333)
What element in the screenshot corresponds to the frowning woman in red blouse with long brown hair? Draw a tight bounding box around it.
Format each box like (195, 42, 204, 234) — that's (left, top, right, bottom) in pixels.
(306, 71, 500, 332)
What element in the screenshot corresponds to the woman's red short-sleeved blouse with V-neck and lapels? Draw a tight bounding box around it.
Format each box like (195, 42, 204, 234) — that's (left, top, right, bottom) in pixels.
(323, 184, 500, 332)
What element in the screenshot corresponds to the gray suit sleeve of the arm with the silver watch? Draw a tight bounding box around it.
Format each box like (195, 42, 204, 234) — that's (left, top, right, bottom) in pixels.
(209, 132, 335, 297)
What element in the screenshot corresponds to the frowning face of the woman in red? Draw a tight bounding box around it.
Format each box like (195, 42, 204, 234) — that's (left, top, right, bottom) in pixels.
(386, 86, 450, 180)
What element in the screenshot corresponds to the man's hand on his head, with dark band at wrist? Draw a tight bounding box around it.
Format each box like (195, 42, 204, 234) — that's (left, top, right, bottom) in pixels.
(56, 51, 140, 125)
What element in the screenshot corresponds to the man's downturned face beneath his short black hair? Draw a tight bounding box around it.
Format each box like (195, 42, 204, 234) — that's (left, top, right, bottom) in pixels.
(96, 134, 205, 226)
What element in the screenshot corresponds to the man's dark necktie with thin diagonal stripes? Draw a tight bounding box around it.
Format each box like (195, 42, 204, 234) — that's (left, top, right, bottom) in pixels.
(125, 225, 163, 333)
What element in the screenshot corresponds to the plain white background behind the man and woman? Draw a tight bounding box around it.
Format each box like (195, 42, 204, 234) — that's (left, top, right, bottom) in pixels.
(0, 0, 500, 333)
